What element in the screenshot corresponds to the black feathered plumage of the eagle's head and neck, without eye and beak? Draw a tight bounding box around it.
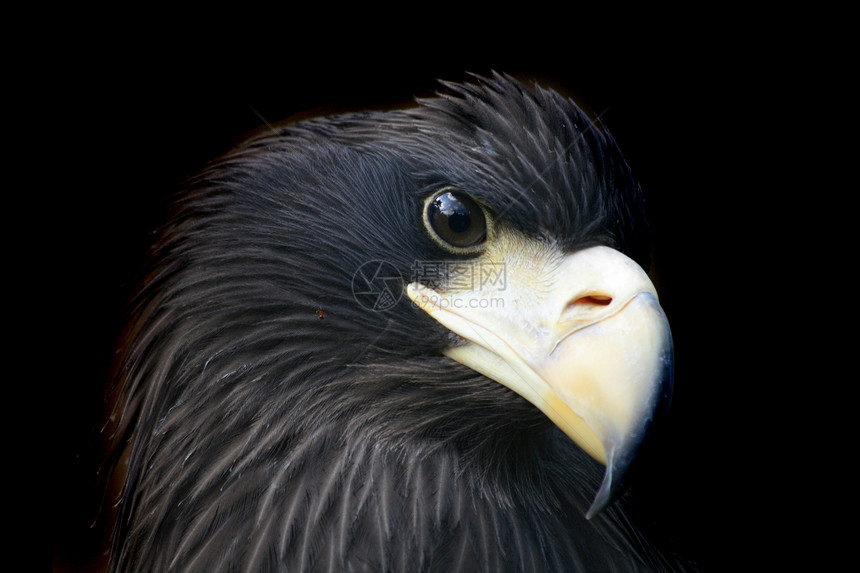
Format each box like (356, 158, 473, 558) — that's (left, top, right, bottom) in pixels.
(102, 73, 692, 572)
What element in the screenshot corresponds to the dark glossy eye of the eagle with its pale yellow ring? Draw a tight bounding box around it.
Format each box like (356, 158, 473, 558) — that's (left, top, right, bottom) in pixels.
(424, 187, 487, 252)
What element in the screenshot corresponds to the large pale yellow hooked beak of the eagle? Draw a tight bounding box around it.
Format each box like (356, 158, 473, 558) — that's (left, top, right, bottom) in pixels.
(407, 245, 673, 517)
